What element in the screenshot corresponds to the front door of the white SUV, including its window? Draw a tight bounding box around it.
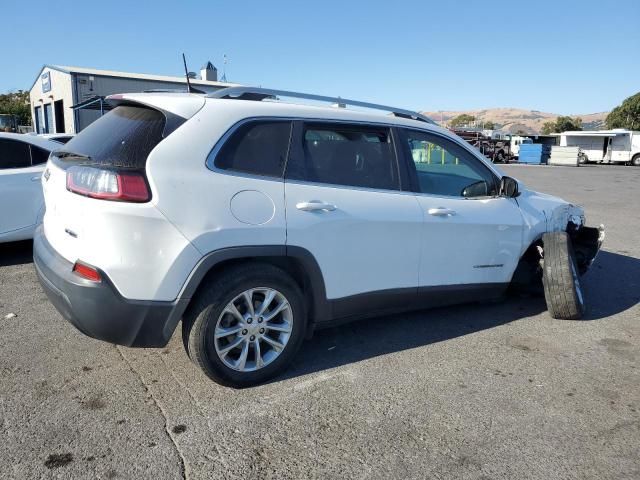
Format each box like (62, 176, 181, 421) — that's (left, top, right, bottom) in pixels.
(400, 129, 523, 291)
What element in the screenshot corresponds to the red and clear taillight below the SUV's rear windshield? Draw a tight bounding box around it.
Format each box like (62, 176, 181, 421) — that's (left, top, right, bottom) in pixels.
(67, 166, 151, 202)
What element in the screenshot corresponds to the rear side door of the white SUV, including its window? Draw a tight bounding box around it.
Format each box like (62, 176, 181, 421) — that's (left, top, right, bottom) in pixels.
(285, 122, 422, 316)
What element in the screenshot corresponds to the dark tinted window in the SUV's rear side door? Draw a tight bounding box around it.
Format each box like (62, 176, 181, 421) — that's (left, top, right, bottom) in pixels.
(287, 123, 400, 190)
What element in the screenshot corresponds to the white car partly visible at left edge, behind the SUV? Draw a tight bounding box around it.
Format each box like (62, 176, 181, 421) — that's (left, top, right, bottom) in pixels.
(0, 133, 62, 243)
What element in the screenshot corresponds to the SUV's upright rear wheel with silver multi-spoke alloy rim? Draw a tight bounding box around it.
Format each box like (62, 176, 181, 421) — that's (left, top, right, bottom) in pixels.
(182, 263, 307, 388)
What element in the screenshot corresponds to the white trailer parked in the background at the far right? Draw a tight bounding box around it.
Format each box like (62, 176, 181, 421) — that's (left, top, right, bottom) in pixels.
(560, 128, 640, 166)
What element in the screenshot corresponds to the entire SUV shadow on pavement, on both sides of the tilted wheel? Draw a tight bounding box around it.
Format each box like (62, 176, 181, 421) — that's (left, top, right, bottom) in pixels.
(282, 251, 640, 382)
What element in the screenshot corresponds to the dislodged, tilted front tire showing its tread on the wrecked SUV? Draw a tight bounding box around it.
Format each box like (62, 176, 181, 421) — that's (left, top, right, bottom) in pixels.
(542, 232, 585, 320)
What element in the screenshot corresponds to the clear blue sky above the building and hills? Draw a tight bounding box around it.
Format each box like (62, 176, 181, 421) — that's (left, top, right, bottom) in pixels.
(0, 0, 640, 114)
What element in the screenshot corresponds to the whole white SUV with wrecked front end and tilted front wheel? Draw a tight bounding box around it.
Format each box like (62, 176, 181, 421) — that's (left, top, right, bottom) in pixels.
(34, 87, 603, 387)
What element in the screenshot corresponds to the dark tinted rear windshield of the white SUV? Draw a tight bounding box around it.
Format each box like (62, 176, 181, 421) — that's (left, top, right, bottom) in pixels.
(55, 105, 165, 169)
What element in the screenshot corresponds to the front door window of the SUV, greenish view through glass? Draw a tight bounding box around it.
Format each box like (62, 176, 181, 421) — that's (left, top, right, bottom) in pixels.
(405, 130, 497, 198)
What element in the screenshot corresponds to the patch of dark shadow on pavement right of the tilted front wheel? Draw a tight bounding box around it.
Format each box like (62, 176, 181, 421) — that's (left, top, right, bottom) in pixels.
(583, 251, 640, 320)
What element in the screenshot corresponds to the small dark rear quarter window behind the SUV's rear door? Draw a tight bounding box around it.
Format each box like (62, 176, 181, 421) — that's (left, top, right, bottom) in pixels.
(214, 120, 291, 177)
